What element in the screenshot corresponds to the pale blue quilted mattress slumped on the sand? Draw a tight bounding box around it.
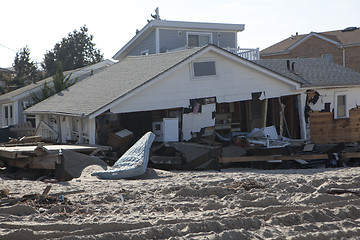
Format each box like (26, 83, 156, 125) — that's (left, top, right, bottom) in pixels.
(91, 132, 155, 179)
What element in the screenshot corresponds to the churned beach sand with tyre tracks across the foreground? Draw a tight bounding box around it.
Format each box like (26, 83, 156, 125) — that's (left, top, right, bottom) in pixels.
(0, 166, 360, 239)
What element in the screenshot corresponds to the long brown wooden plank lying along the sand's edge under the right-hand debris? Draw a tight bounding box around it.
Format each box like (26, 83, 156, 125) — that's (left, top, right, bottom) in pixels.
(219, 154, 328, 163)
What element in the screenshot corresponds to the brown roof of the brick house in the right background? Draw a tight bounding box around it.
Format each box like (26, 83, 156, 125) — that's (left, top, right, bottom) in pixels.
(260, 27, 360, 55)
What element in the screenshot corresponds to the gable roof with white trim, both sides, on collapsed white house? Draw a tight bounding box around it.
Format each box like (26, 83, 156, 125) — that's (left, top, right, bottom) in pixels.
(25, 44, 299, 118)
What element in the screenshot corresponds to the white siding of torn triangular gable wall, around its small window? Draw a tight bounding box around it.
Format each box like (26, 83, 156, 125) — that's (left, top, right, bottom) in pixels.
(110, 52, 293, 113)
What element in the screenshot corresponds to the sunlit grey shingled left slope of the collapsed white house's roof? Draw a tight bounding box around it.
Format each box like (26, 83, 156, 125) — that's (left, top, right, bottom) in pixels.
(26, 48, 201, 116)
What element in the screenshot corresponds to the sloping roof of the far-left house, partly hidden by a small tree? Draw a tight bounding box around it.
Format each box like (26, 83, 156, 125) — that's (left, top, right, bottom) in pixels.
(0, 60, 114, 103)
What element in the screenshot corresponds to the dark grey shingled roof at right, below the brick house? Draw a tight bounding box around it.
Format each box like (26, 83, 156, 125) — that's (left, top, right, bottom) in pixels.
(253, 58, 360, 87)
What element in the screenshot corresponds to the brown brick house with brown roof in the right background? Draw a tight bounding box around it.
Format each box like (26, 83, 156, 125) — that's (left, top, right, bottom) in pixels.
(260, 27, 360, 72)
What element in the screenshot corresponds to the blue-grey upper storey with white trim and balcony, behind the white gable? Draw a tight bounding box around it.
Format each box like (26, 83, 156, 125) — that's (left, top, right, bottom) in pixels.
(113, 19, 259, 60)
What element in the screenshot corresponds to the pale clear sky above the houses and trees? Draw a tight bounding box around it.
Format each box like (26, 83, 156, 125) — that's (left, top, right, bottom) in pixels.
(0, 0, 360, 68)
